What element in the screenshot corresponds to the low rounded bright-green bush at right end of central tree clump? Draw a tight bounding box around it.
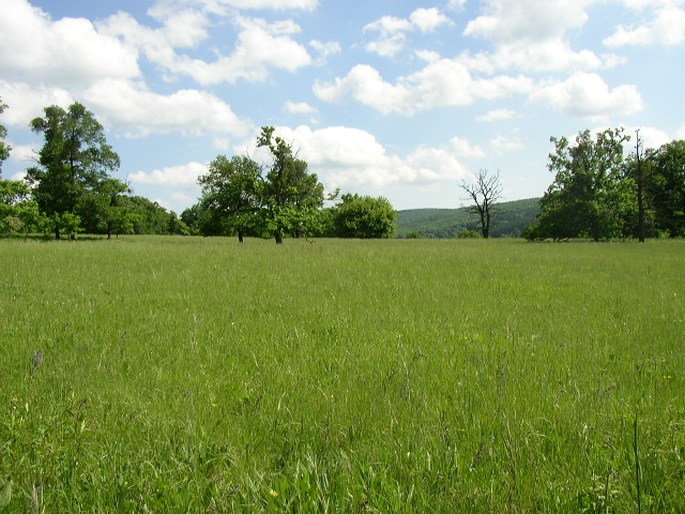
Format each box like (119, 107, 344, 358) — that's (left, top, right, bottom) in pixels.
(333, 194, 397, 239)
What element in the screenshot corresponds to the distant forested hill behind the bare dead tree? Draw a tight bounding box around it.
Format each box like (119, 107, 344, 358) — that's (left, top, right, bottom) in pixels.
(397, 198, 540, 239)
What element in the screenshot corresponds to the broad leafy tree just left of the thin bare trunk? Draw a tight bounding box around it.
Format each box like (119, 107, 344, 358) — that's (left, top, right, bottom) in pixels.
(526, 128, 636, 241)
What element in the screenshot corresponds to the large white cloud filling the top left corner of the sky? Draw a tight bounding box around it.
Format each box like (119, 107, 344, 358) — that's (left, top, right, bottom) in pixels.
(0, 0, 140, 87)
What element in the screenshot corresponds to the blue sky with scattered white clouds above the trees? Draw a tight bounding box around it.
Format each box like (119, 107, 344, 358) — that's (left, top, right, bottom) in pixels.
(0, 0, 685, 214)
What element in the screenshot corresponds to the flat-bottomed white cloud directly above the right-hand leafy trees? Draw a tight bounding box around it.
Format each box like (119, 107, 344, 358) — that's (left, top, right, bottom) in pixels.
(530, 73, 644, 118)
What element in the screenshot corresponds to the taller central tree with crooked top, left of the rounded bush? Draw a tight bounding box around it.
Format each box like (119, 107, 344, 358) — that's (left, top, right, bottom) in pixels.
(257, 127, 324, 244)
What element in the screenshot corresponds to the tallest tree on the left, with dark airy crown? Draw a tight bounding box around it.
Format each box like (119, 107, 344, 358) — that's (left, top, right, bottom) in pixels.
(27, 103, 119, 239)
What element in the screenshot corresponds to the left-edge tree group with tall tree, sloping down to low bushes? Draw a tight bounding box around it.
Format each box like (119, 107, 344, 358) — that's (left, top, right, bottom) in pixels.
(0, 101, 188, 239)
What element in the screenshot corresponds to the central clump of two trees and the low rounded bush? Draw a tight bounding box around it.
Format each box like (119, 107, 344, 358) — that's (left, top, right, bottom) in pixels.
(181, 126, 397, 243)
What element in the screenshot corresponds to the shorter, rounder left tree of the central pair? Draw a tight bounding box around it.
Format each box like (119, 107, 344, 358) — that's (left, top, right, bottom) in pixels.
(199, 155, 263, 243)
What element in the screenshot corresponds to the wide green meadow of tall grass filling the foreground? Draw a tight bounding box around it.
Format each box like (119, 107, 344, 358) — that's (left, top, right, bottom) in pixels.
(0, 237, 685, 513)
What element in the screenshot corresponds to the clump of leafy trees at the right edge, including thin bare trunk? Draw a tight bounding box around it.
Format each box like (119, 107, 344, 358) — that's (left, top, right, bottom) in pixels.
(524, 128, 685, 241)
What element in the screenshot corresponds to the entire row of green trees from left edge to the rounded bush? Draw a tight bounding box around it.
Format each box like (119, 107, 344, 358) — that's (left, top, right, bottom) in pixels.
(0, 100, 397, 243)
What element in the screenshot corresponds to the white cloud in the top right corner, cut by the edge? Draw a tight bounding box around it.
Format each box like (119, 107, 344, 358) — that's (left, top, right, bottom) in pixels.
(604, 2, 685, 47)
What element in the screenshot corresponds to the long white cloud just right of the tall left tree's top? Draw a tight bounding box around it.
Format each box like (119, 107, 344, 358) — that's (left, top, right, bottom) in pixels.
(83, 81, 251, 137)
